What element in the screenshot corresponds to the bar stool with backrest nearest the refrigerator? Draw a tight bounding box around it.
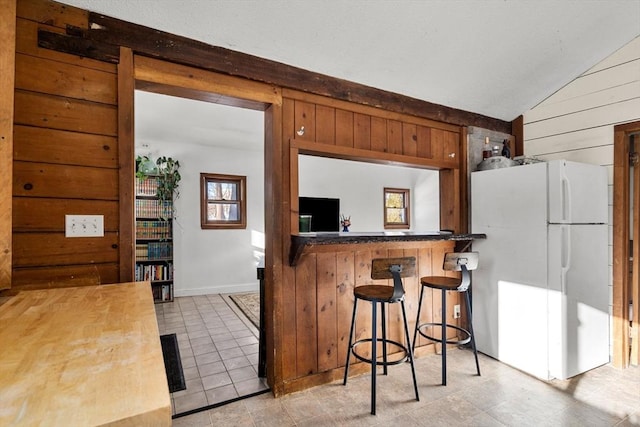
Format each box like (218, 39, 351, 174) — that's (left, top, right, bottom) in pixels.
(413, 252, 480, 385)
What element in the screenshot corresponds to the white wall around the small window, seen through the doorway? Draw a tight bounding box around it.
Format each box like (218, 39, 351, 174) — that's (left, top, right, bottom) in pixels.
(140, 141, 264, 296)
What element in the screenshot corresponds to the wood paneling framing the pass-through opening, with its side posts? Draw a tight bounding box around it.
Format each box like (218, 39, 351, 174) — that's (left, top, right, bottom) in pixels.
(282, 89, 467, 241)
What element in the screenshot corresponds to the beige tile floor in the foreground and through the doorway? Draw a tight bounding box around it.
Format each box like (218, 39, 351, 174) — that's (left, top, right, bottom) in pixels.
(158, 295, 640, 427)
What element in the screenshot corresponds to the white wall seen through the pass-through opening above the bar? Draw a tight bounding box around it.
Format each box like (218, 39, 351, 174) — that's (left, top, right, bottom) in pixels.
(298, 155, 440, 232)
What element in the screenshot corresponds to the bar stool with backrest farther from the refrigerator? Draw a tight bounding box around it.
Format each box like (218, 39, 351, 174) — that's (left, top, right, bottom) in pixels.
(343, 257, 420, 415)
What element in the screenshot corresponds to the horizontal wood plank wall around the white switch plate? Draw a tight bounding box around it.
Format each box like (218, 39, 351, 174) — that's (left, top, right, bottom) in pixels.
(12, 1, 119, 290)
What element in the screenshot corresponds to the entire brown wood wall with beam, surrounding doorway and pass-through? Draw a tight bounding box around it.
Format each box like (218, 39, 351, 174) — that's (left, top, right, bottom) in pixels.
(7, 0, 505, 395)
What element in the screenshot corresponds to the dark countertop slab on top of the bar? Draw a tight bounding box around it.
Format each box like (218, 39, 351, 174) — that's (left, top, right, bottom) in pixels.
(289, 231, 487, 266)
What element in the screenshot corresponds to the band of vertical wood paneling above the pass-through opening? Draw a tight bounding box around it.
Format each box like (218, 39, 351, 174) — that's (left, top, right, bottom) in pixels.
(283, 90, 461, 169)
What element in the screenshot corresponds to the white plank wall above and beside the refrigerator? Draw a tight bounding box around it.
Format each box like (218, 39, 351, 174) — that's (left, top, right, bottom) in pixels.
(524, 37, 640, 352)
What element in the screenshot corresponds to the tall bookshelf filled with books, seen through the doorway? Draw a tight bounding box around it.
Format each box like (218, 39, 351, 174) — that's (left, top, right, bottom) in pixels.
(134, 175, 173, 303)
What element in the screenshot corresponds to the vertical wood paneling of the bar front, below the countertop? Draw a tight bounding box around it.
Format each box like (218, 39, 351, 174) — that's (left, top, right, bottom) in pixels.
(281, 241, 458, 393)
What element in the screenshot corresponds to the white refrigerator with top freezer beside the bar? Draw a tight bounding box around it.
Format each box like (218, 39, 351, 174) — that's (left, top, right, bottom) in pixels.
(471, 160, 609, 380)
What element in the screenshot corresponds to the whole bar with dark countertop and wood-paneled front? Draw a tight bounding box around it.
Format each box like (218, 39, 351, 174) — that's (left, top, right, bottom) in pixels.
(283, 232, 486, 393)
